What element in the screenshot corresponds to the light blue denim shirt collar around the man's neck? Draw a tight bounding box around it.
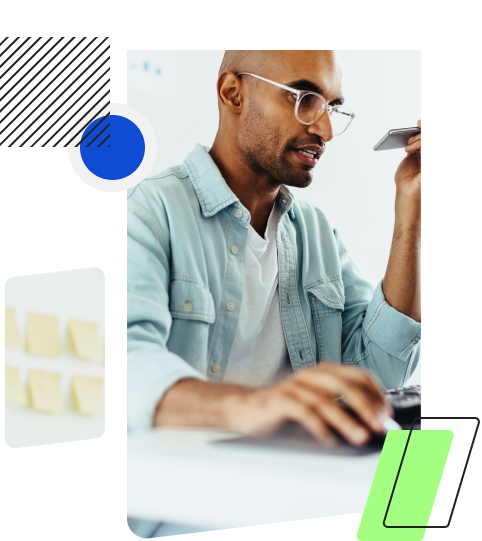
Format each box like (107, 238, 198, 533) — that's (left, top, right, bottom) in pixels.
(183, 143, 295, 226)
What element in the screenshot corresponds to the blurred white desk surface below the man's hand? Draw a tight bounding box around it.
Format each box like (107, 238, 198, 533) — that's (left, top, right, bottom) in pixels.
(127, 428, 380, 528)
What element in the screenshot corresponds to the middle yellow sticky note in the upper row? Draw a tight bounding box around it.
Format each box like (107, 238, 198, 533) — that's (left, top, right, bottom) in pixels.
(26, 312, 60, 357)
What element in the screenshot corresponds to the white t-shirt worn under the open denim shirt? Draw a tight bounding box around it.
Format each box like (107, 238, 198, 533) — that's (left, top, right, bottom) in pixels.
(223, 202, 294, 387)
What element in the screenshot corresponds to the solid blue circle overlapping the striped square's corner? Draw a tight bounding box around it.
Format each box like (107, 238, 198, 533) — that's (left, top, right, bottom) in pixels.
(80, 115, 146, 180)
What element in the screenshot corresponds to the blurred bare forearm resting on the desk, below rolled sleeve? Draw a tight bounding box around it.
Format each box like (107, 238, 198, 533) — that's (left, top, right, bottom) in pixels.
(153, 378, 250, 430)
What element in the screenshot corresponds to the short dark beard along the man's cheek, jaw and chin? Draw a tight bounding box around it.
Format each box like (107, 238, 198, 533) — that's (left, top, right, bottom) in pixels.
(238, 100, 313, 188)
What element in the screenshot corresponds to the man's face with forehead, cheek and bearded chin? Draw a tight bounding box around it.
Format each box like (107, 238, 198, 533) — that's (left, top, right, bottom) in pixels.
(238, 51, 343, 188)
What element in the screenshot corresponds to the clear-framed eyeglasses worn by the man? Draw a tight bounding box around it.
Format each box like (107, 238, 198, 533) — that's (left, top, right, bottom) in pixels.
(237, 72, 355, 135)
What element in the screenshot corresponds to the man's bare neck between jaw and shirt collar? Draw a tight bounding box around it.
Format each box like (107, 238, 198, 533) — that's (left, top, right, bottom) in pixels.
(209, 130, 280, 237)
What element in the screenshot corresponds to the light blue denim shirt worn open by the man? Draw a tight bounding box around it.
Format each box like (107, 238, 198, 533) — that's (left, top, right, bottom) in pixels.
(127, 144, 420, 430)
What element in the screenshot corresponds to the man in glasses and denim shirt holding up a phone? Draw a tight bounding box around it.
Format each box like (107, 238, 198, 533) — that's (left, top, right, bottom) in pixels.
(128, 51, 421, 445)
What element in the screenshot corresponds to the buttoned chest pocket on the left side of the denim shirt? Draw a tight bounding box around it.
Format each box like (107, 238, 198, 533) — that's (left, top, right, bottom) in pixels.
(169, 276, 216, 323)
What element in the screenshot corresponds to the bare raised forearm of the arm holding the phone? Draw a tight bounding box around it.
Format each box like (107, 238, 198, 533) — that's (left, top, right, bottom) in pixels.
(382, 194, 421, 322)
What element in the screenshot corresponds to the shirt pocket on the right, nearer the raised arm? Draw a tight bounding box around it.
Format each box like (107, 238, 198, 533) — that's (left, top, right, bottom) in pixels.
(305, 274, 345, 362)
